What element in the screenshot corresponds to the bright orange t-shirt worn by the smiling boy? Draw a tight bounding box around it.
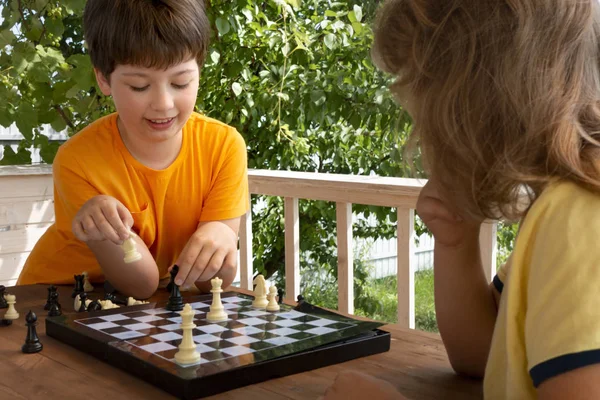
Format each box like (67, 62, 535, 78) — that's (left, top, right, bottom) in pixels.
(17, 113, 249, 285)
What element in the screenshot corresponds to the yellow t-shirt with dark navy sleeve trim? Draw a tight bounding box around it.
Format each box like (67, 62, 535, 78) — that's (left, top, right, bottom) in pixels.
(484, 182, 600, 400)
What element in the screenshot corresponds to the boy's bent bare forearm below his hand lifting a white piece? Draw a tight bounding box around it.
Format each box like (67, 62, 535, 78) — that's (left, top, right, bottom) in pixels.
(87, 235, 159, 299)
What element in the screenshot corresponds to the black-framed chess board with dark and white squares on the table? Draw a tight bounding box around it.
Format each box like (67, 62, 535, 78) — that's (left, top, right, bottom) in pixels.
(46, 293, 390, 399)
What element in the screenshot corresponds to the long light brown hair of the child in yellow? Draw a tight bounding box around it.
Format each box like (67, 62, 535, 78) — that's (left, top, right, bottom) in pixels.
(373, 0, 600, 218)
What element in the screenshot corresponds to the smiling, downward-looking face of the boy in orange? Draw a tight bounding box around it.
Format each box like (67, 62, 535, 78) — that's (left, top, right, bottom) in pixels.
(95, 59, 200, 144)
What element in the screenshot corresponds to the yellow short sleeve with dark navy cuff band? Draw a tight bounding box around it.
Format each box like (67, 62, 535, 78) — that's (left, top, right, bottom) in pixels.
(524, 192, 600, 387)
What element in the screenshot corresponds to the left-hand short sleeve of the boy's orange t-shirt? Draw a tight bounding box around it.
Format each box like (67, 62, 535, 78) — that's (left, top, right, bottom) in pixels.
(52, 148, 100, 231)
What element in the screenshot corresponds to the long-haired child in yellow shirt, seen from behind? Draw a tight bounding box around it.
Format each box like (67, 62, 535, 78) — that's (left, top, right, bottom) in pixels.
(326, 0, 600, 399)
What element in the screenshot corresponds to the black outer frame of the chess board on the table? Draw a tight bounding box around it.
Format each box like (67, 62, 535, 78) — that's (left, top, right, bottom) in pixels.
(46, 295, 391, 400)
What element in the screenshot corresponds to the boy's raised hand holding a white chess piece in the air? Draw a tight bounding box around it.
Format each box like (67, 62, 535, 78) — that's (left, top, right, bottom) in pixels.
(72, 195, 133, 245)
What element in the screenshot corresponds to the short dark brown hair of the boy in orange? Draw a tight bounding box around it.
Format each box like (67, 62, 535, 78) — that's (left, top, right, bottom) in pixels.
(83, 0, 210, 79)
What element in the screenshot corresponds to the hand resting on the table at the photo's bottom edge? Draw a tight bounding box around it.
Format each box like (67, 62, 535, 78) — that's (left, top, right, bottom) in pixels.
(323, 371, 406, 400)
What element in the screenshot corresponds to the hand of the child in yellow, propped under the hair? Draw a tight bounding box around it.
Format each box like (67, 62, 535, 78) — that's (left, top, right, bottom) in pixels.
(417, 178, 482, 247)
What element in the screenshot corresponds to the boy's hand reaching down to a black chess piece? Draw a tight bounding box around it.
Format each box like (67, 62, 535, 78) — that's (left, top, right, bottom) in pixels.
(175, 221, 237, 287)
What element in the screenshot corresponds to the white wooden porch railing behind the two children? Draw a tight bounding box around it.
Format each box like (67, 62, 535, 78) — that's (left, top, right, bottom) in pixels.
(0, 166, 496, 328)
